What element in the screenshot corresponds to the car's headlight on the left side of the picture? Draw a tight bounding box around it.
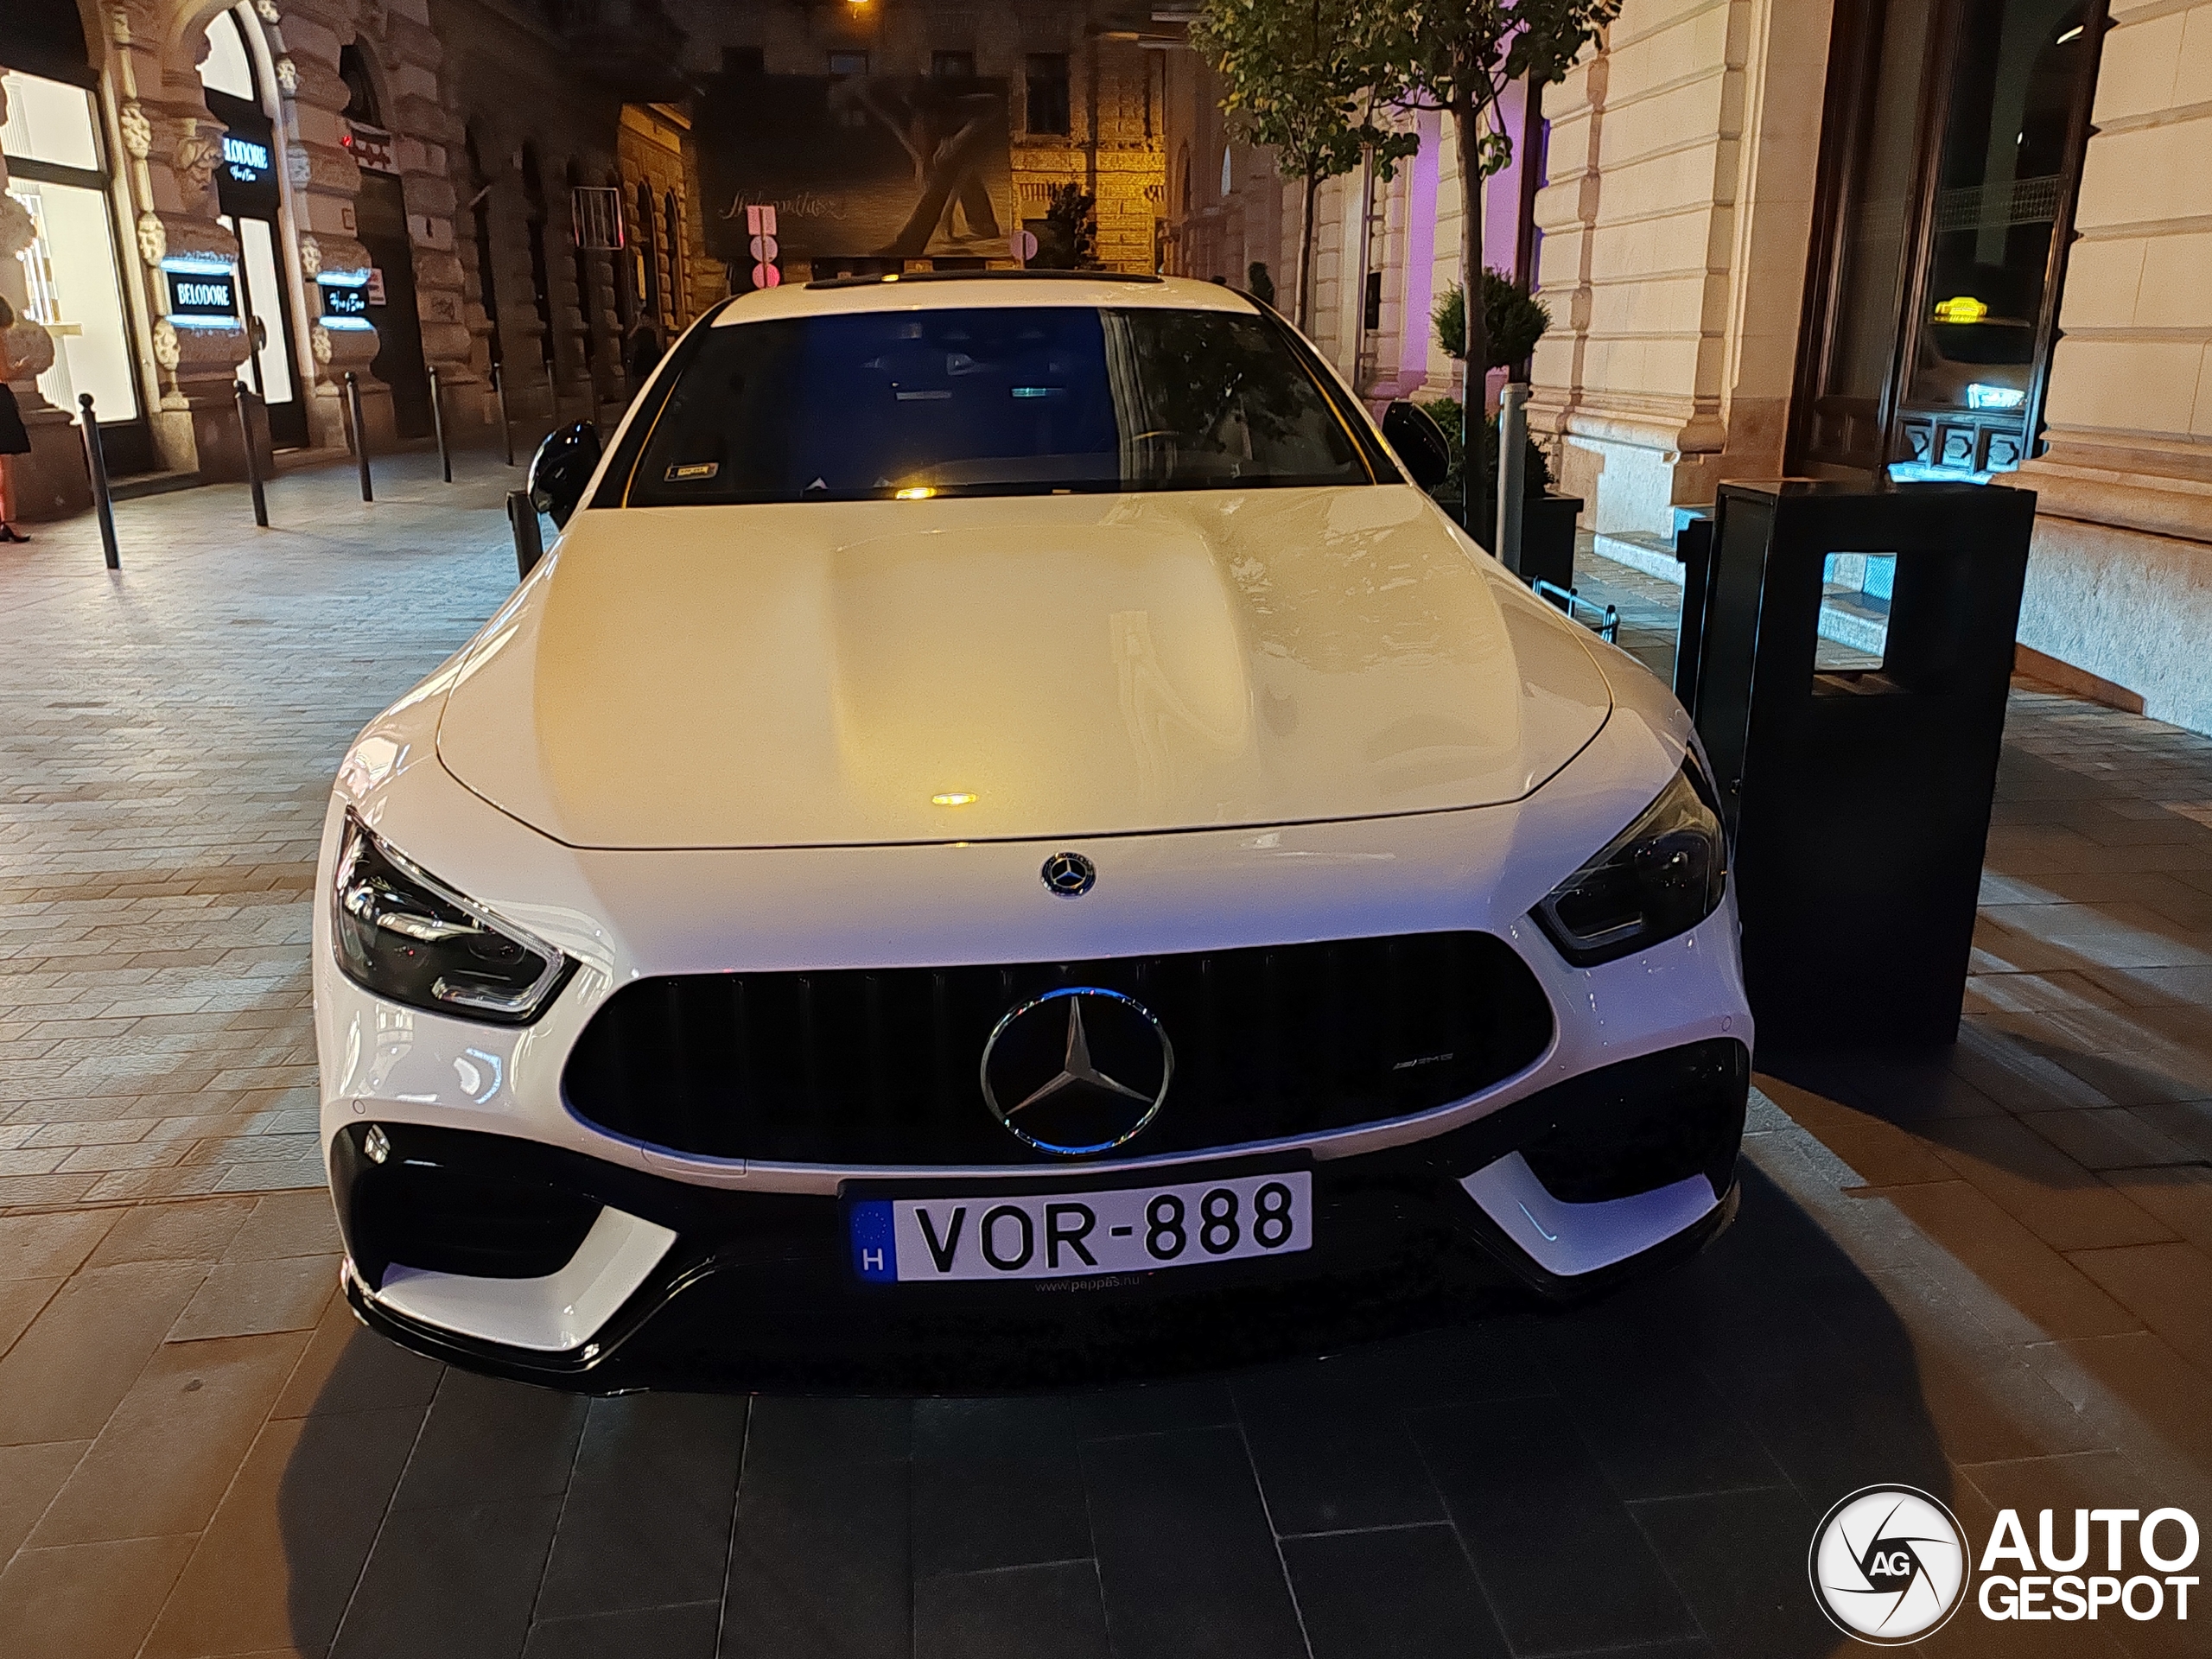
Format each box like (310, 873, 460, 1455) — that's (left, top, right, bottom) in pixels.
(329, 812, 570, 1027)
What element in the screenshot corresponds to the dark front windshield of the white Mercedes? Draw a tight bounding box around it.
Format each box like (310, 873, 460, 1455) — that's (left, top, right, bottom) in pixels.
(626, 305, 1374, 506)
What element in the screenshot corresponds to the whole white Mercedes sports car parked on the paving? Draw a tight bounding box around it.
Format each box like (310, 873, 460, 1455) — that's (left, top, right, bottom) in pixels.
(315, 274, 1752, 1391)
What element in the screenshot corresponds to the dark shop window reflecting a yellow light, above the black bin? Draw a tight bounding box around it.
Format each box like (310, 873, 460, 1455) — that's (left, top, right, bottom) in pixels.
(1787, 0, 2101, 480)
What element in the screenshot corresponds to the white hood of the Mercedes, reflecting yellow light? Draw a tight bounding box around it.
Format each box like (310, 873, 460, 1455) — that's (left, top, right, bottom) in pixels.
(438, 486, 1611, 847)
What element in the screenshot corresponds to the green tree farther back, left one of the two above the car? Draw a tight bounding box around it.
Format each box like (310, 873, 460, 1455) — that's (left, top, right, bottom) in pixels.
(1190, 0, 1421, 327)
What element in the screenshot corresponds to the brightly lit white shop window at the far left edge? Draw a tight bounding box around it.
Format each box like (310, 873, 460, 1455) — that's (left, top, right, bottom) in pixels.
(0, 71, 139, 425)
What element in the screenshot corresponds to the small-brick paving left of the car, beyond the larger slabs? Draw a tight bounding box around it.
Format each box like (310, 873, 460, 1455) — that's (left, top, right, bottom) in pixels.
(0, 454, 515, 1212)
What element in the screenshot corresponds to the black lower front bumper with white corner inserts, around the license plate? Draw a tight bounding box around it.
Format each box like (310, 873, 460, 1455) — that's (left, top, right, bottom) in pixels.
(329, 1039, 1750, 1394)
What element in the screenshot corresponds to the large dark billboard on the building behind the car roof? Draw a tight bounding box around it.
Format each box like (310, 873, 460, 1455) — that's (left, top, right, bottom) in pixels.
(692, 75, 1015, 279)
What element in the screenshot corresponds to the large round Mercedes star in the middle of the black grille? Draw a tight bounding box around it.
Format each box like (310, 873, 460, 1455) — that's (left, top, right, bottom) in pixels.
(982, 986, 1174, 1157)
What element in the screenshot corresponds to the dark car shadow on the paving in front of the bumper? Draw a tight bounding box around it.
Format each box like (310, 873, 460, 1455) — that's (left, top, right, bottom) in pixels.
(276, 1161, 1951, 1659)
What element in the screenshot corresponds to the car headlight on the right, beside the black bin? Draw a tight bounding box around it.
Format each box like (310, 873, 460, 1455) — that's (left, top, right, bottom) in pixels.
(1535, 757, 1727, 967)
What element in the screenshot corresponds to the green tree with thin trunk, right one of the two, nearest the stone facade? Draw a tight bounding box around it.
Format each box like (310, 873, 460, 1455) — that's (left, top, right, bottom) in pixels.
(1356, 0, 1621, 398)
